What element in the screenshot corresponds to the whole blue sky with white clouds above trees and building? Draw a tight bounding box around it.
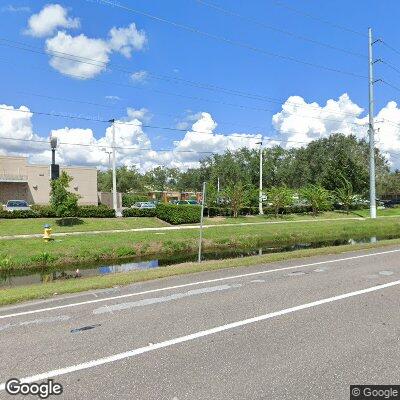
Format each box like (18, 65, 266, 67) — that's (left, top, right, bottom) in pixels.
(0, 0, 400, 171)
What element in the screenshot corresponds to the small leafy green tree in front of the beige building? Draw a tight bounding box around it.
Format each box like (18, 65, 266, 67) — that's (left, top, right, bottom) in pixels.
(50, 171, 79, 220)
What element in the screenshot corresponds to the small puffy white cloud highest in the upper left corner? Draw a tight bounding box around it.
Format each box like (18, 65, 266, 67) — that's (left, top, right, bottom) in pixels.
(25, 4, 80, 37)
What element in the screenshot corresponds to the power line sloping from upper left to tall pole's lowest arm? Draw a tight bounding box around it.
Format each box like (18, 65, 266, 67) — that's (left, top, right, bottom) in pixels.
(86, 0, 367, 79)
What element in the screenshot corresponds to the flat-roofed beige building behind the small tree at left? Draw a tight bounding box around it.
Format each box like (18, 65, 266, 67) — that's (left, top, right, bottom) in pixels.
(0, 156, 97, 205)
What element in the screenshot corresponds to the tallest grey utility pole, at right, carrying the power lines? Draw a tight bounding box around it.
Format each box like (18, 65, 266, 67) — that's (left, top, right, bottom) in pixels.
(368, 28, 376, 218)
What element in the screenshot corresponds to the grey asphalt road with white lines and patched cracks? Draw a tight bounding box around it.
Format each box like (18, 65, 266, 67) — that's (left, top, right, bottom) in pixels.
(0, 247, 400, 400)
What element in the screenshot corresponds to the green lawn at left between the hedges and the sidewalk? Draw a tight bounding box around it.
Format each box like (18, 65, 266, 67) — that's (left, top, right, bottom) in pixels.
(0, 217, 168, 236)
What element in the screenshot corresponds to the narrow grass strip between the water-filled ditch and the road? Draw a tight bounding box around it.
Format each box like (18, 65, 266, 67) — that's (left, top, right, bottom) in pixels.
(0, 239, 400, 305)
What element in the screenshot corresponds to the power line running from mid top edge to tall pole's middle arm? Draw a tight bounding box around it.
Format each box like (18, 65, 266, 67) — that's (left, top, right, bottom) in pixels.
(195, 0, 367, 59)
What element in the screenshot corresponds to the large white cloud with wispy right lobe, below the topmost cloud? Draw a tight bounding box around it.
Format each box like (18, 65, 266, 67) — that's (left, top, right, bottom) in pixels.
(46, 23, 146, 79)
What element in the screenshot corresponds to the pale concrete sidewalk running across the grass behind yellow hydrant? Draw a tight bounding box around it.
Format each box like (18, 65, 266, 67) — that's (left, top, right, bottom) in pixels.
(0, 217, 365, 240)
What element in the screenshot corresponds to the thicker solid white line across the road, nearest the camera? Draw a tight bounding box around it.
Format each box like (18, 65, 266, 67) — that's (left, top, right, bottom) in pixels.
(0, 280, 400, 391)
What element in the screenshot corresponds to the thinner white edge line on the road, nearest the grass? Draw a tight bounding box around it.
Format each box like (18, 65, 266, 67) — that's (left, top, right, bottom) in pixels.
(0, 249, 400, 319)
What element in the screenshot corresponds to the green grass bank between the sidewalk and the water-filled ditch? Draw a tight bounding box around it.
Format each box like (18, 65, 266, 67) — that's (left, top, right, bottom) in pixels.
(0, 217, 400, 269)
